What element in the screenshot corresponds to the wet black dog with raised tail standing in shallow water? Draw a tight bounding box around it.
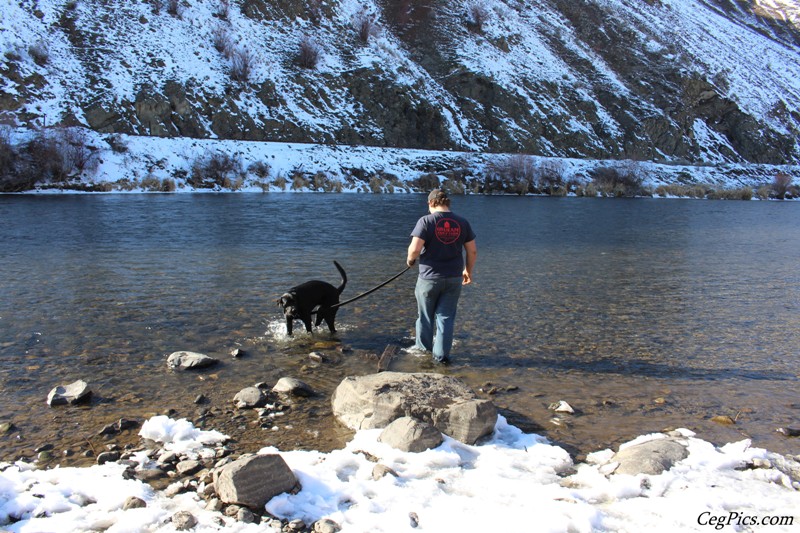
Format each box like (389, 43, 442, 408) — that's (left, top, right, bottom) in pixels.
(278, 261, 347, 335)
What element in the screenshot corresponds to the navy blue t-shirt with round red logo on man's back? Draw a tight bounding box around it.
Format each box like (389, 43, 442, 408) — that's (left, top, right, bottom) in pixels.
(411, 211, 475, 279)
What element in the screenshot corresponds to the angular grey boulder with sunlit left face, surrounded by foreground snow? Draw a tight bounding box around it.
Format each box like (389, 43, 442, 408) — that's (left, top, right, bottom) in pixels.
(214, 454, 299, 512)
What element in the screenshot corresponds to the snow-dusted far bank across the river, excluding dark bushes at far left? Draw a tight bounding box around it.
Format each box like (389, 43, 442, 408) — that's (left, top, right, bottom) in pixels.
(8, 128, 800, 195)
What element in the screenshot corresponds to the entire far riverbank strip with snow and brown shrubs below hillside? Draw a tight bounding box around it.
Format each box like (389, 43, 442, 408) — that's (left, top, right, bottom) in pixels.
(0, 128, 800, 199)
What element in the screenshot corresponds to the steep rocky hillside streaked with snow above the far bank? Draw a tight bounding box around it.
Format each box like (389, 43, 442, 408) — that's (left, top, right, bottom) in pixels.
(0, 0, 800, 165)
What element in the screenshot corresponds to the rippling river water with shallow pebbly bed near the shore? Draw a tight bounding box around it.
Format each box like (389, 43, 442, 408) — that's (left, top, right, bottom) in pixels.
(0, 193, 800, 464)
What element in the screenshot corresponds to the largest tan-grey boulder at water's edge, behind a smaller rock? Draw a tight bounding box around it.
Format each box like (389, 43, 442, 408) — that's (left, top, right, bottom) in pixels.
(332, 372, 497, 444)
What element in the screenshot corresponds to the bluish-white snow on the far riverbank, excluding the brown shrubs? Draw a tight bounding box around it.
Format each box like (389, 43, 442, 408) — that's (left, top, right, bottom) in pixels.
(11, 128, 800, 192)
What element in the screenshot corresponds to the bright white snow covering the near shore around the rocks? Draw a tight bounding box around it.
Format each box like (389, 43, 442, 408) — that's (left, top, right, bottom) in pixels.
(0, 416, 800, 532)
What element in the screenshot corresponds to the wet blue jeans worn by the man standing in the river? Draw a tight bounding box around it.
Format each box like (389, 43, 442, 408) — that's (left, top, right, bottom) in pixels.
(414, 276, 462, 362)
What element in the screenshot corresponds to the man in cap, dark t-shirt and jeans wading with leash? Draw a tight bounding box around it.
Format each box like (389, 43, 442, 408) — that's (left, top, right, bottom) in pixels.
(406, 189, 478, 363)
